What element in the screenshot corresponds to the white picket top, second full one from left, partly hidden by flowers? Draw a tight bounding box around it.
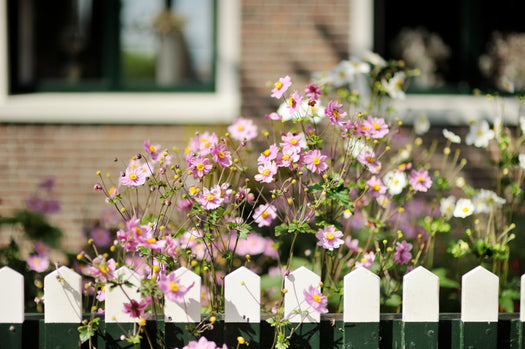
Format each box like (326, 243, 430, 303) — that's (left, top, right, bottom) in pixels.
(104, 267, 141, 323)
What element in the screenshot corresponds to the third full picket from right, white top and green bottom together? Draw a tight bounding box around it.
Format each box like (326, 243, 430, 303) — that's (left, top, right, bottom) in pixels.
(343, 267, 380, 349)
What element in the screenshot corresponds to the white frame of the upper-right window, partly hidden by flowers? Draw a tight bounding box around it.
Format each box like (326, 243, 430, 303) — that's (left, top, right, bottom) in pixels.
(349, 0, 519, 126)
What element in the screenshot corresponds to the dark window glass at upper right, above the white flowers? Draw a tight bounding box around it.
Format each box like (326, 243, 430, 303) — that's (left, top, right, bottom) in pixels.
(374, 0, 525, 94)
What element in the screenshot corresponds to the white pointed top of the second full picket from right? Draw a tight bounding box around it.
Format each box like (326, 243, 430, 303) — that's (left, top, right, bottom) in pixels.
(402, 266, 439, 322)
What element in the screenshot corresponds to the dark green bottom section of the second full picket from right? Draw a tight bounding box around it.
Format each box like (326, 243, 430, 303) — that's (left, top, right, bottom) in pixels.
(402, 322, 439, 349)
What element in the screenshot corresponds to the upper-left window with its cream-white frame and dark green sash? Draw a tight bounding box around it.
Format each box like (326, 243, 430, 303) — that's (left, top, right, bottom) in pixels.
(0, 0, 241, 123)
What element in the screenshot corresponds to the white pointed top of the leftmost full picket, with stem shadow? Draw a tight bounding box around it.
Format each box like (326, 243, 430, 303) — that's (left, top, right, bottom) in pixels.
(44, 266, 82, 323)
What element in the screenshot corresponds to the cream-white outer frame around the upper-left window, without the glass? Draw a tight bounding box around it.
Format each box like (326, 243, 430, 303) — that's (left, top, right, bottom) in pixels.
(0, 0, 241, 124)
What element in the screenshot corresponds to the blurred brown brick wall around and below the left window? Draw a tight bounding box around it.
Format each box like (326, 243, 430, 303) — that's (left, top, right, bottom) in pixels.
(0, 0, 349, 252)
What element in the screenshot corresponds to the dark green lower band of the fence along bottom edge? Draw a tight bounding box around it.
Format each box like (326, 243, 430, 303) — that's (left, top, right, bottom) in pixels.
(0, 313, 525, 349)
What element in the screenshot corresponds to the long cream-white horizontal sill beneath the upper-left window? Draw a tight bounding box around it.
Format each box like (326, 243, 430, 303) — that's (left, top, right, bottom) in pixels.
(0, 93, 240, 124)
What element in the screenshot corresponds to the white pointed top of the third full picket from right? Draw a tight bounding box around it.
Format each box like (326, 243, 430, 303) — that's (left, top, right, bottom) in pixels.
(343, 267, 380, 322)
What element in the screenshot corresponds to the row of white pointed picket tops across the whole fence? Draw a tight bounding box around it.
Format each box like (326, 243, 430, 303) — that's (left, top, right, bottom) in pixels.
(0, 266, 525, 324)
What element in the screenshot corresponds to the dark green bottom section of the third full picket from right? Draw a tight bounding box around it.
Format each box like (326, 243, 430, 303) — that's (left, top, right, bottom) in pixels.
(344, 322, 379, 349)
